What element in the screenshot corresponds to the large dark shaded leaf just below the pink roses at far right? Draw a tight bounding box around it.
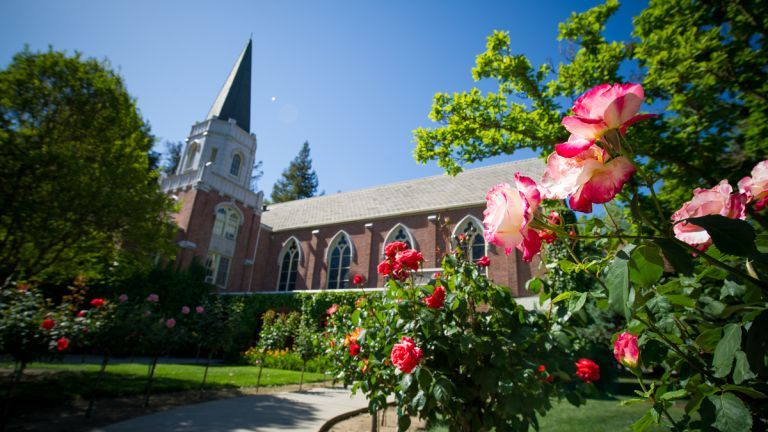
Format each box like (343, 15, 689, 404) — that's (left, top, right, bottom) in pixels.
(682, 215, 761, 257)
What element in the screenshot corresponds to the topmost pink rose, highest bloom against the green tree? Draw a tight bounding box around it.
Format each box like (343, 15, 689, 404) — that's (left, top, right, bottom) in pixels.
(555, 84, 655, 158)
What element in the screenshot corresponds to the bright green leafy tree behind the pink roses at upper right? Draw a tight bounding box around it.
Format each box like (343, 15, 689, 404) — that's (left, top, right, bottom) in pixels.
(414, 0, 768, 210)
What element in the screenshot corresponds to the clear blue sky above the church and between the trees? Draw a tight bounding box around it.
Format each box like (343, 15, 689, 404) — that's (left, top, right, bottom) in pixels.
(0, 0, 646, 195)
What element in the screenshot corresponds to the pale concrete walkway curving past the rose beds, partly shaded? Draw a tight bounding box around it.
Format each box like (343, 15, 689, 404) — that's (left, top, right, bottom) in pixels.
(92, 388, 368, 432)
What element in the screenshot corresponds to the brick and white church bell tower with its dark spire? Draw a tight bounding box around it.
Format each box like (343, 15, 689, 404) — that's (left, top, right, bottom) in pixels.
(160, 40, 263, 291)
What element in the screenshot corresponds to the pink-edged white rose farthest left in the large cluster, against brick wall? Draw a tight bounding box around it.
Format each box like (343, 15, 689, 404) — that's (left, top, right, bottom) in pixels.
(483, 173, 541, 261)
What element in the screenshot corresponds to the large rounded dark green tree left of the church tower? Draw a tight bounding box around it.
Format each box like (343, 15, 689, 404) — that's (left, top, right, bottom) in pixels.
(0, 49, 173, 284)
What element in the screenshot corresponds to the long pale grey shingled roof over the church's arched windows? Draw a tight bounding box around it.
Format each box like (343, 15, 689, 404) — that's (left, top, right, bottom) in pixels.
(261, 159, 545, 231)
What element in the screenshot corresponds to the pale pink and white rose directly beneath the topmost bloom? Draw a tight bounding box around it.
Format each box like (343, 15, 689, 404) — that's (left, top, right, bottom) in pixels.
(541, 145, 635, 213)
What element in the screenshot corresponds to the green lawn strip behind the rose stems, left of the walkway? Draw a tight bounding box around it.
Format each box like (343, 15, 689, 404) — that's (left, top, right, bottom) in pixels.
(0, 362, 326, 404)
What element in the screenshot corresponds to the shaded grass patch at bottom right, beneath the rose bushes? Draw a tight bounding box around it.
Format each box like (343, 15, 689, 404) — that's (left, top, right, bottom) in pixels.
(429, 399, 682, 432)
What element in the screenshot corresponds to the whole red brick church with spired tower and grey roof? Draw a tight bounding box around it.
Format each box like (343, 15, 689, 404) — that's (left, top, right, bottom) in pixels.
(161, 41, 544, 295)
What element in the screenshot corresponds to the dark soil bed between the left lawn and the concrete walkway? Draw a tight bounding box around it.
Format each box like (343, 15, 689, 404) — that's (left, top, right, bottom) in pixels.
(0, 371, 329, 432)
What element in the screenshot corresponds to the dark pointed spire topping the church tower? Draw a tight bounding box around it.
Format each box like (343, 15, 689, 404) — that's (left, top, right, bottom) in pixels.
(206, 39, 251, 132)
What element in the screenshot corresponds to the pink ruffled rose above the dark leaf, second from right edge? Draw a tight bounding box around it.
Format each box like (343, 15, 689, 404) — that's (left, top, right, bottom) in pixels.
(672, 180, 747, 250)
